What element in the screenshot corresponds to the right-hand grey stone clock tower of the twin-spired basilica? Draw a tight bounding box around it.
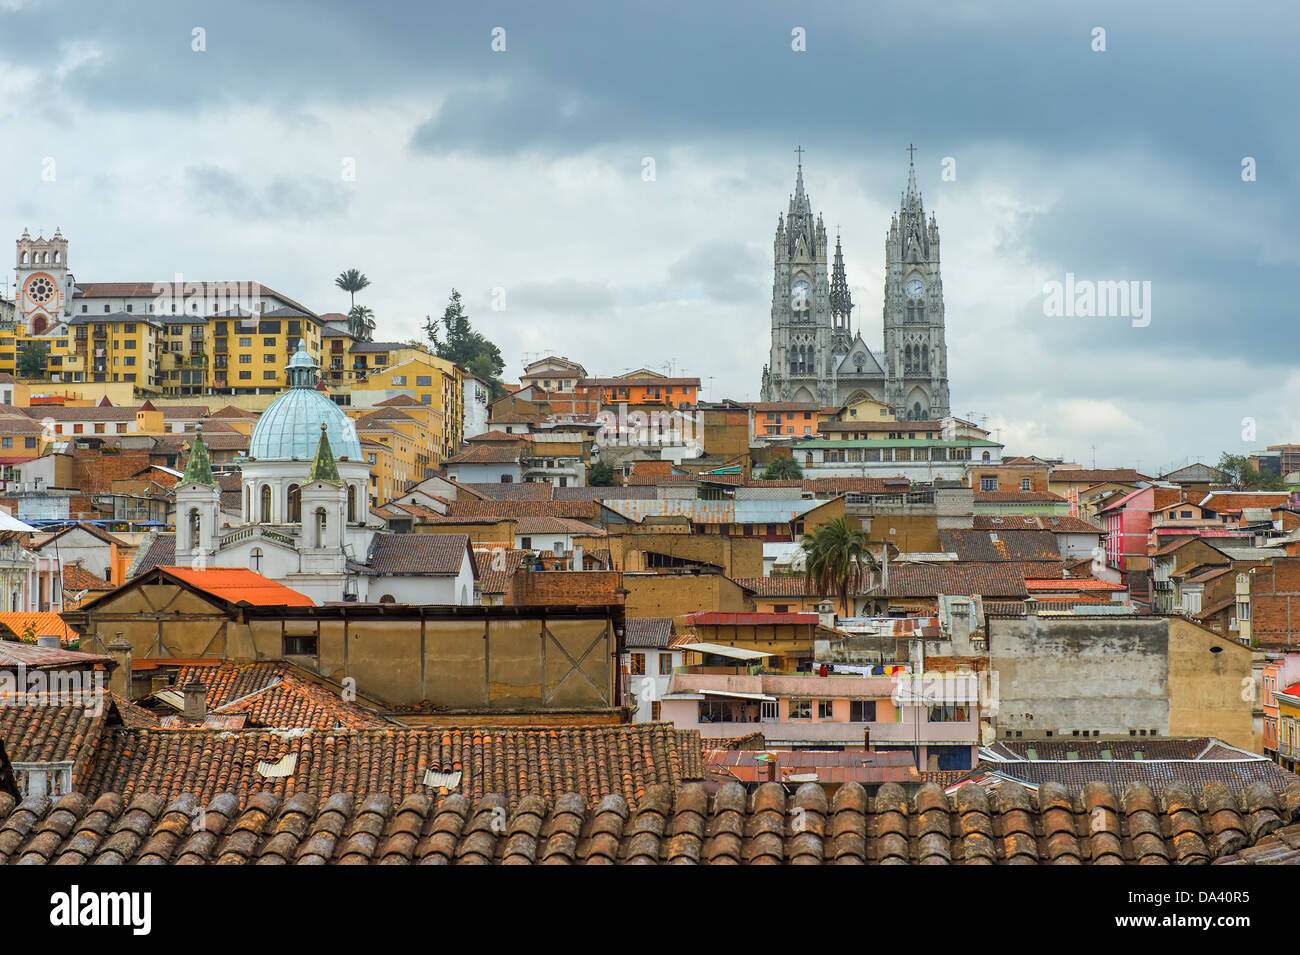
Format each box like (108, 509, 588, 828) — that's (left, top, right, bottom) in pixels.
(884, 149, 949, 421)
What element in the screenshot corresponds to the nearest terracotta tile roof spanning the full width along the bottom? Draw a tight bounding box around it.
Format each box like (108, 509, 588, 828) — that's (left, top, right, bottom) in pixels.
(0, 779, 1300, 865)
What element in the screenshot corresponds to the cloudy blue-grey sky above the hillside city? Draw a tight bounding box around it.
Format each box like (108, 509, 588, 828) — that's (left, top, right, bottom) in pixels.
(0, 0, 1300, 472)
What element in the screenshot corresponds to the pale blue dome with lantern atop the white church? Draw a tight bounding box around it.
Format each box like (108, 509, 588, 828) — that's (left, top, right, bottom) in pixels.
(248, 342, 363, 461)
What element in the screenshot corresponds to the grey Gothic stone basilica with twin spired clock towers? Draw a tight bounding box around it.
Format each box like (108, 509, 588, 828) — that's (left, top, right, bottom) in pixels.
(762, 152, 949, 421)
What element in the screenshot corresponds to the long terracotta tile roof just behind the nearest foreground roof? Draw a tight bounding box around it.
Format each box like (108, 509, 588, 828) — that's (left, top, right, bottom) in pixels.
(73, 722, 703, 804)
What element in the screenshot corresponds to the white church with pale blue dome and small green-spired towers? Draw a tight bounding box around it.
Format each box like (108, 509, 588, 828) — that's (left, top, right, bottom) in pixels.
(154, 347, 477, 604)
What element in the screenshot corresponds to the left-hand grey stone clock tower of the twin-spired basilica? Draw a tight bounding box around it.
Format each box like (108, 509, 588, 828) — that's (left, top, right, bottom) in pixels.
(763, 149, 848, 404)
